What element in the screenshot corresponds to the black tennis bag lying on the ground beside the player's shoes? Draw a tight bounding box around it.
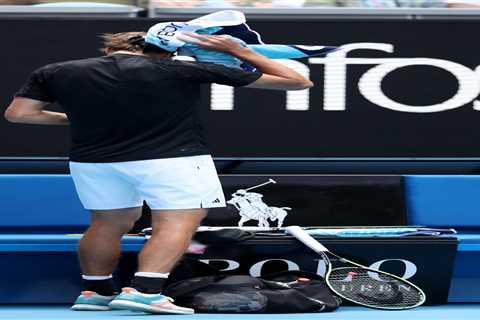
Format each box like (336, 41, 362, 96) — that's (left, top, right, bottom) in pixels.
(165, 271, 341, 313)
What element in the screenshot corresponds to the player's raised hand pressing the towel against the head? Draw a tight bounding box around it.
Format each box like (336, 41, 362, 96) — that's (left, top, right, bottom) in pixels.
(177, 32, 248, 54)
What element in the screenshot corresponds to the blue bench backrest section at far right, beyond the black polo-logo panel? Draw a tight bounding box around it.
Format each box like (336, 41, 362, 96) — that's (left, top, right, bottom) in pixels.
(405, 175, 480, 228)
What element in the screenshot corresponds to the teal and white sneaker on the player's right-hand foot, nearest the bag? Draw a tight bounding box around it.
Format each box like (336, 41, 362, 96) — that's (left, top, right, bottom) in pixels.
(109, 288, 194, 314)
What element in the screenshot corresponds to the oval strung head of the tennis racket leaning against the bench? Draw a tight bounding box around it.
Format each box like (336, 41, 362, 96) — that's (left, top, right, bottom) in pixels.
(327, 268, 424, 309)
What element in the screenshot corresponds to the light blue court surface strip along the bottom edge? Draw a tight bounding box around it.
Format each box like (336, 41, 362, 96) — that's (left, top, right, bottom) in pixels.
(0, 304, 480, 320)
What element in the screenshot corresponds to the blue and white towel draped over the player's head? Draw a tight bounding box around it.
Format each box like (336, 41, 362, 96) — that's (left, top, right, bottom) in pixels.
(145, 10, 338, 70)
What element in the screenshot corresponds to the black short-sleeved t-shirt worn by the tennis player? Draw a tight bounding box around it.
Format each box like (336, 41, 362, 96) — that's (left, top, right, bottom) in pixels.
(16, 54, 261, 162)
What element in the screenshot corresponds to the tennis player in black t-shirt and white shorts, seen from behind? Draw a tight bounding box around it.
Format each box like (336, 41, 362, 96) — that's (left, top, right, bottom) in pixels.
(5, 32, 312, 314)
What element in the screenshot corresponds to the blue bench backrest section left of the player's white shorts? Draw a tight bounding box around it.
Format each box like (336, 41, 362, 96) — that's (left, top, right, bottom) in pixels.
(0, 174, 90, 227)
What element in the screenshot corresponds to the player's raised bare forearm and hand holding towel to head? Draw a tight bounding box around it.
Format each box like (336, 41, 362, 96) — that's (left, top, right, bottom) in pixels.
(178, 32, 313, 90)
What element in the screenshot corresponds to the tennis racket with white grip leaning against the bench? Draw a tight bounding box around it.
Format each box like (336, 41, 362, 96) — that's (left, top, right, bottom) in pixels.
(285, 226, 426, 310)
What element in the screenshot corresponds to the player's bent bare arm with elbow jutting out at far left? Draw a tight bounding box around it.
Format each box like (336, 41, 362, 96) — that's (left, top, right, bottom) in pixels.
(5, 97, 69, 125)
